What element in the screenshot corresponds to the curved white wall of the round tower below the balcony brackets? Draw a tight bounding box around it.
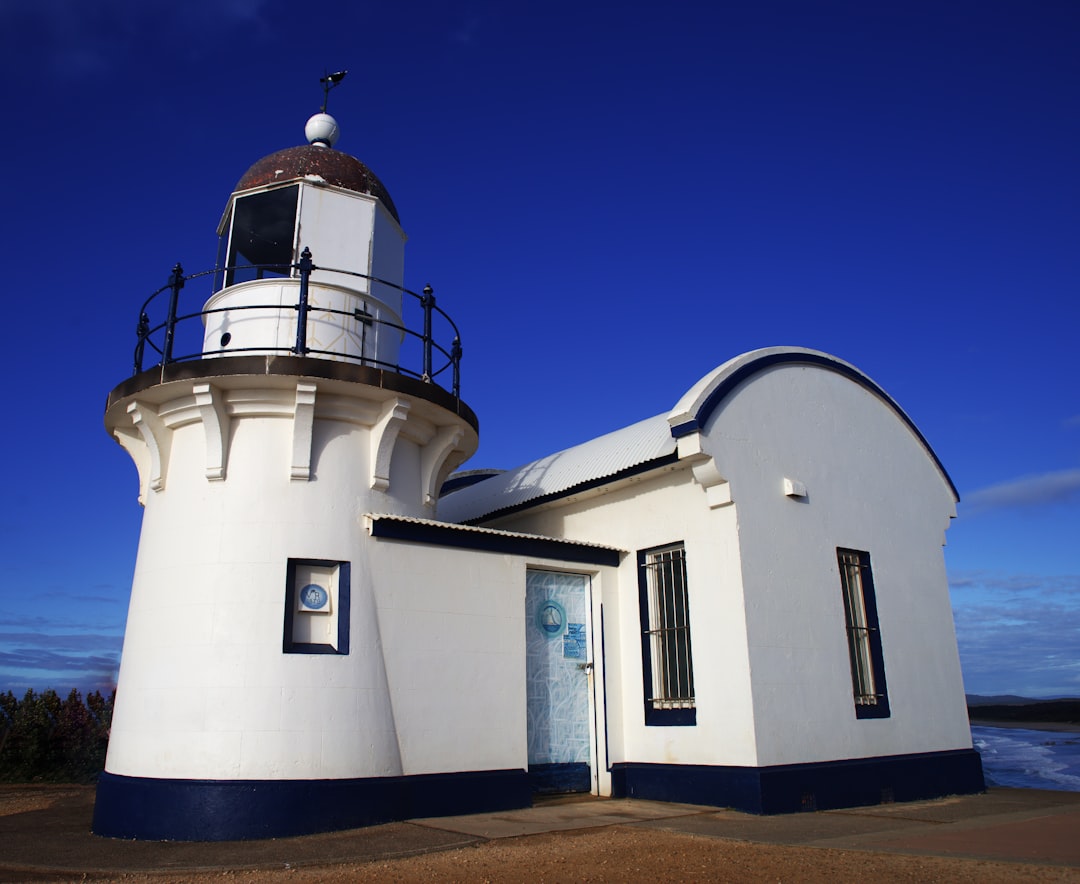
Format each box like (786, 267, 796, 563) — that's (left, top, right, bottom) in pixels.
(108, 419, 400, 779)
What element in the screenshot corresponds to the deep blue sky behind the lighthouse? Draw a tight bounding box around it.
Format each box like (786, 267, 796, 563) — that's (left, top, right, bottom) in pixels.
(0, 0, 1080, 696)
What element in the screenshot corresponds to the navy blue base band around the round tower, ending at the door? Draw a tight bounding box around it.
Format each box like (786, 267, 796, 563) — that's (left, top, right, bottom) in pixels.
(92, 771, 532, 841)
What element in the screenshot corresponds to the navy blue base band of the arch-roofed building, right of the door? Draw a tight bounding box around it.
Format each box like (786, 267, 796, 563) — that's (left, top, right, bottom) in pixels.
(611, 749, 986, 814)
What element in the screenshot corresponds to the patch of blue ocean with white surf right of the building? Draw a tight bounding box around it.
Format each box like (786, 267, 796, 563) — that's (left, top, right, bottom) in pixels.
(971, 724, 1080, 792)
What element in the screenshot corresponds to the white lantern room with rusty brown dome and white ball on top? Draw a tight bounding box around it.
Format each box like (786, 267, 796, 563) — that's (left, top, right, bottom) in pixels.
(203, 113, 406, 367)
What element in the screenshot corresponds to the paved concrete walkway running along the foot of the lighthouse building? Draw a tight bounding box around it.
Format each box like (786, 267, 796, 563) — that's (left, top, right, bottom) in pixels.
(0, 787, 1080, 882)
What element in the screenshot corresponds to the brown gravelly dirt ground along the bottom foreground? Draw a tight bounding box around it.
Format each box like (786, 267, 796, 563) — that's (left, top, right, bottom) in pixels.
(0, 787, 1080, 884)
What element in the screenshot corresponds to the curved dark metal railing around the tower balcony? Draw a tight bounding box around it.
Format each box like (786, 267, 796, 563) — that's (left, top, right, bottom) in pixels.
(133, 248, 461, 398)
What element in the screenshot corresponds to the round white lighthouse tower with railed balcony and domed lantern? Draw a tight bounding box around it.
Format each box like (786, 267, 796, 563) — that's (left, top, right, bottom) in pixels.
(94, 100, 486, 840)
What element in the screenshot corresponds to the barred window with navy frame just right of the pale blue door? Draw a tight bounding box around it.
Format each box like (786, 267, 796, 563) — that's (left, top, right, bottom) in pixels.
(637, 543, 697, 725)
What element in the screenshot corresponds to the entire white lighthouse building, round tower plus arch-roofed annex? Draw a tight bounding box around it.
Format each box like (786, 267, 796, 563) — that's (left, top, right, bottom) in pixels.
(94, 113, 983, 840)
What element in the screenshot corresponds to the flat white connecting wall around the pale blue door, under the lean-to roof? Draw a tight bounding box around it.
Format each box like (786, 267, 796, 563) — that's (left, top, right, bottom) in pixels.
(368, 539, 615, 794)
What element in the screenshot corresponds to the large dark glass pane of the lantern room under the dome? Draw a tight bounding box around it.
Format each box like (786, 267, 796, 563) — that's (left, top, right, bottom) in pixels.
(225, 185, 299, 285)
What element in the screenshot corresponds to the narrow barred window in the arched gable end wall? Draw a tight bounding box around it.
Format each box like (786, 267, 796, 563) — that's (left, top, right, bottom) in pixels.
(836, 549, 889, 718)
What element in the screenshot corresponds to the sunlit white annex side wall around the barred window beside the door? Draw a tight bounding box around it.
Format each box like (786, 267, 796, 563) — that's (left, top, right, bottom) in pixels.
(492, 467, 757, 765)
